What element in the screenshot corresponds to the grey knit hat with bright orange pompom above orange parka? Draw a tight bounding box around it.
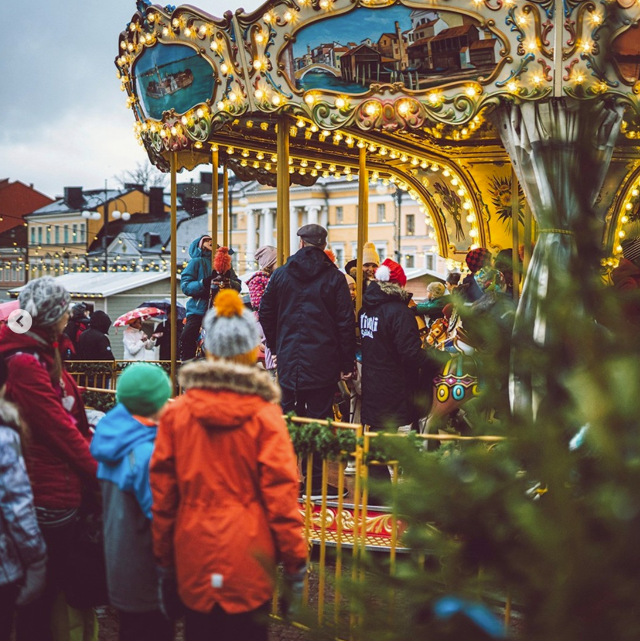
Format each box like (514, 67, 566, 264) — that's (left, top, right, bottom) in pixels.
(202, 289, 260, 360)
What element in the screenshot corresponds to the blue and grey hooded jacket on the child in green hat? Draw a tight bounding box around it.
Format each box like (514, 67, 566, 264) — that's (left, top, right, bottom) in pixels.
(91, 403, 160, 612)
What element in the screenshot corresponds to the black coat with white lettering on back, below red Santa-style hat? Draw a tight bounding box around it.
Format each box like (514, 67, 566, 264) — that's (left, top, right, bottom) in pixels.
(358, 282, 431, 428)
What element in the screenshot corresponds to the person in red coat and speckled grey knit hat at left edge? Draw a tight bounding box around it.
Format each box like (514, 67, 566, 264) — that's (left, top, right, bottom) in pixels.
(0, 276, 99, 641)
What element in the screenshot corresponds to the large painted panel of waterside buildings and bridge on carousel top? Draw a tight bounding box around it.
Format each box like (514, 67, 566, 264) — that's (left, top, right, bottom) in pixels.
(283, 5, 501, 94)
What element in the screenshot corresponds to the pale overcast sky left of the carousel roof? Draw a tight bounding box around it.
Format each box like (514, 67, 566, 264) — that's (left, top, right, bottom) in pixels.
(0, 0, 262, 197)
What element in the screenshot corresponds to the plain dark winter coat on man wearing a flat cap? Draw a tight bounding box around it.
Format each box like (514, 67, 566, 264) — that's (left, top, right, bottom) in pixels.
(260, 246, 356, 390)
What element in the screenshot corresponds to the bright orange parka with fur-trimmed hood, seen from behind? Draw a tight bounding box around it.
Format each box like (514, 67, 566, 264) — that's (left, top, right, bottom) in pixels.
(150, 361, 307, 614)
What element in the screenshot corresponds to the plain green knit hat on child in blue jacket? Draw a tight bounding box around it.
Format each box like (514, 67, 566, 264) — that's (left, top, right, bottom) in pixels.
(116, 363, 171, 416)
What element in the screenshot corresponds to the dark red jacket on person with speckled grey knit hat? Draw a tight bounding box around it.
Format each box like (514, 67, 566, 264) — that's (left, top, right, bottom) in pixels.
(0, 325, 98, 509)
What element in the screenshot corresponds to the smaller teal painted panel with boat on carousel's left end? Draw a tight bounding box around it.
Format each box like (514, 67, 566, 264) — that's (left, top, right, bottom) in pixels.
(134, 45, 214, 119)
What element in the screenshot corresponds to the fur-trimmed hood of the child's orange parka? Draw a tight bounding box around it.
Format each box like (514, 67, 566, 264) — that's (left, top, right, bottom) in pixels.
(178, 360, 280, 429)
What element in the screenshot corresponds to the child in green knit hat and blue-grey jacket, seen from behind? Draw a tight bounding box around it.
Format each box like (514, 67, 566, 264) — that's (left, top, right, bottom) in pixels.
(91, 363, 173, 640)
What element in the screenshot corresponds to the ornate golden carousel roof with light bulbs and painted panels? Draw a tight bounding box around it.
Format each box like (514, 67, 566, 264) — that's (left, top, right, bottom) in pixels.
(115, 0, 640, 256)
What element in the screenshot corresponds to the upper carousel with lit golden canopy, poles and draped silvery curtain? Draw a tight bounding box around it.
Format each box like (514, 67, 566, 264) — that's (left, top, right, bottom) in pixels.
(115, 0, 640, 417)
